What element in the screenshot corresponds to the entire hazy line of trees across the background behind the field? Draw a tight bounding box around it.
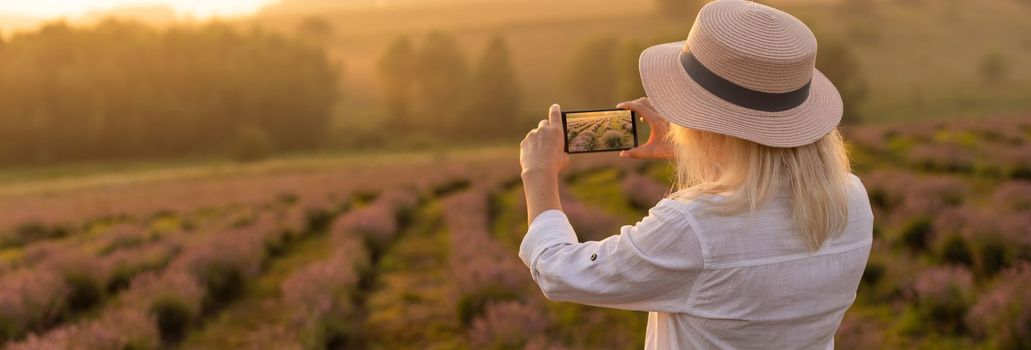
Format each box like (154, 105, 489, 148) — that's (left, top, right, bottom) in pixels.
(0, 15, 865, 164)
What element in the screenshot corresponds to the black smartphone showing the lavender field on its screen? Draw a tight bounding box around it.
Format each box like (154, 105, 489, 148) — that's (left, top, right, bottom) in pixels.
(562, 109, 637, 153)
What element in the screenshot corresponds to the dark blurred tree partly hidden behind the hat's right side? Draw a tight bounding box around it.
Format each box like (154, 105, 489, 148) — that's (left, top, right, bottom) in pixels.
(817, 39, 867, 124)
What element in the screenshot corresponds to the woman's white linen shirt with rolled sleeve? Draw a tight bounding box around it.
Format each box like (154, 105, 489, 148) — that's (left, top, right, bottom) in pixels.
(519, 174, 873, 349)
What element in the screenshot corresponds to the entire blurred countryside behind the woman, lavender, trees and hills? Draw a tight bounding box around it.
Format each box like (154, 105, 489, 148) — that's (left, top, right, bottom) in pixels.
(0, 0, 1031, 349)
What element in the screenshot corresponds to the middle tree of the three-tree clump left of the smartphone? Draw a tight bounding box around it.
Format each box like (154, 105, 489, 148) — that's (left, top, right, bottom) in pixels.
(414, 32, 468, 135)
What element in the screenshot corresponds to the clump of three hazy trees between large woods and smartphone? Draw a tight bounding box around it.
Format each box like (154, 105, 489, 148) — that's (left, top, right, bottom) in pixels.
(378, 32, 523, 139)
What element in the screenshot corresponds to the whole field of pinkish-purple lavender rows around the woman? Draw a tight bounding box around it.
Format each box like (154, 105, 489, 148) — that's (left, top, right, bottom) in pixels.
(0, 117, 1031, 349)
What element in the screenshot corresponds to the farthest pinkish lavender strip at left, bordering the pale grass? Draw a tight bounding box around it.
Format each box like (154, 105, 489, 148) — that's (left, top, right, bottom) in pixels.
(0, 157, 519, 247)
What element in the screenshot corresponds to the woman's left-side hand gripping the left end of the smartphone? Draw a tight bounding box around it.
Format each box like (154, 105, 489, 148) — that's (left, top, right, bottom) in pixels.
(519, 104, 569, 176)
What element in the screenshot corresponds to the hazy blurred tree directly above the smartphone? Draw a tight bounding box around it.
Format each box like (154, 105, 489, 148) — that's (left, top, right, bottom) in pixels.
(563, 36, 619, 106)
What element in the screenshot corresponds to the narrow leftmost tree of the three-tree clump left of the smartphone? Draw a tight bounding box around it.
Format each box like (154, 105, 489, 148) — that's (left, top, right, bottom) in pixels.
(378, 36, 415, 132)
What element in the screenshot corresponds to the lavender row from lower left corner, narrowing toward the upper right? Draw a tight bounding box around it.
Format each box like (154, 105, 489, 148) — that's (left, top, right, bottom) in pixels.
(0, 196, 330, 341)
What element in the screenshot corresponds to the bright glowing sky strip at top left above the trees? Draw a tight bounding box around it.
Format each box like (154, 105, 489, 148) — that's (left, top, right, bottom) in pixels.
(0, 0, 275, 19)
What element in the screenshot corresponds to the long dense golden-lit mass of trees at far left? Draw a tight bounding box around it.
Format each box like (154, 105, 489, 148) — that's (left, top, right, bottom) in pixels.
(0, 21, 339, 164)
